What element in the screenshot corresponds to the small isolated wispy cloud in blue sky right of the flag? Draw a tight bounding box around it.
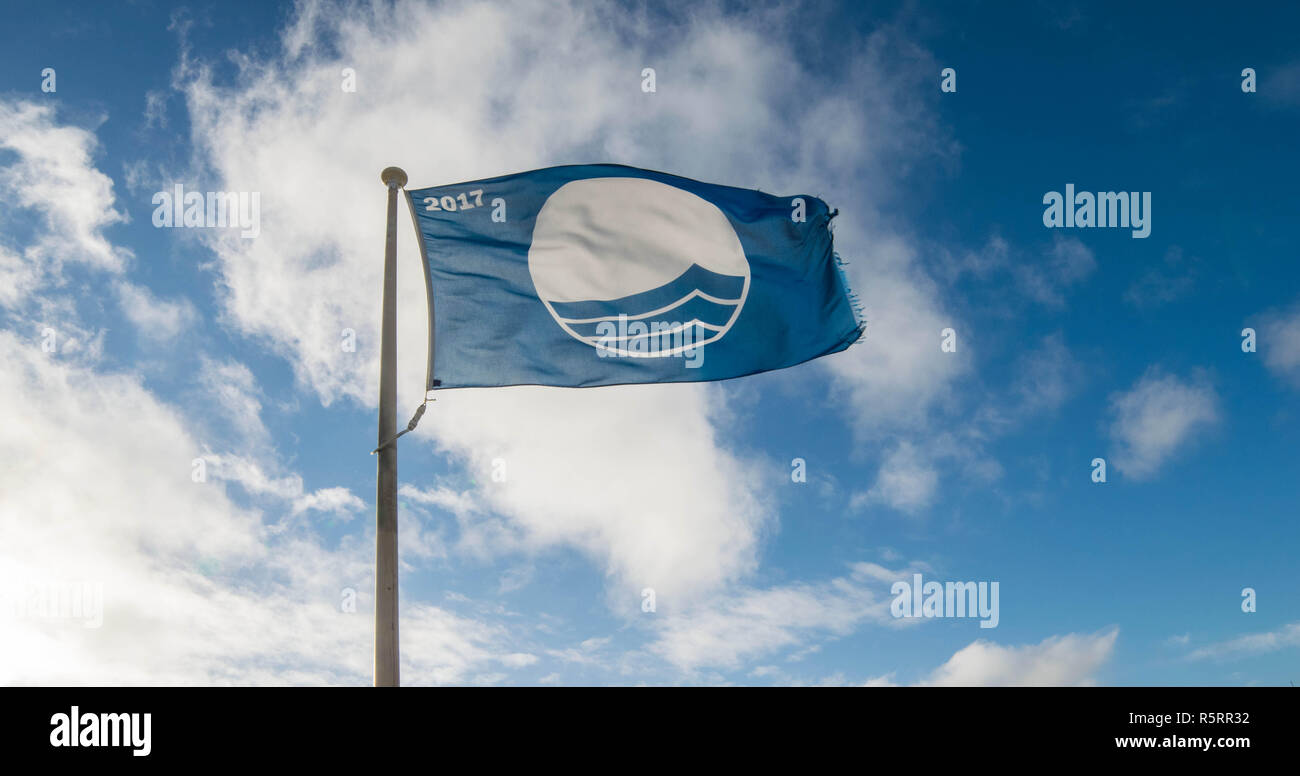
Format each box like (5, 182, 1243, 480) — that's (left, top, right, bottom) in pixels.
(1110, 369, 1219, 480)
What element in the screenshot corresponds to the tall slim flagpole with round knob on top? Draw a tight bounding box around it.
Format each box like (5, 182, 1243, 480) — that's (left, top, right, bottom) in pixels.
(374, 168, 407, 688)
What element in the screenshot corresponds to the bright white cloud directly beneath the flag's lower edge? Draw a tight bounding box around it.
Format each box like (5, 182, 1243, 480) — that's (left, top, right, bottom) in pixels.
(425, 386, 770, 603)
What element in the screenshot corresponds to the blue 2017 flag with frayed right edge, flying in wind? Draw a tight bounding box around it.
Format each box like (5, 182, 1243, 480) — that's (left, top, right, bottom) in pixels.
(407, 165, 863, 389)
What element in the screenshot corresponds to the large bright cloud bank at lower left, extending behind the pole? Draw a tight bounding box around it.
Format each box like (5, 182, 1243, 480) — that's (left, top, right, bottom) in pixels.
(0, 331, 540, 685)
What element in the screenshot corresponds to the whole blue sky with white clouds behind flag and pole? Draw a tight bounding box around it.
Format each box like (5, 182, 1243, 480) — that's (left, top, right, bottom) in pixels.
(0, 3, 1300, 685)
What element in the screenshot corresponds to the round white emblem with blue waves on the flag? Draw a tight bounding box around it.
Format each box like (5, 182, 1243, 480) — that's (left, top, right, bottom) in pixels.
(528, 178, 750, 357)
